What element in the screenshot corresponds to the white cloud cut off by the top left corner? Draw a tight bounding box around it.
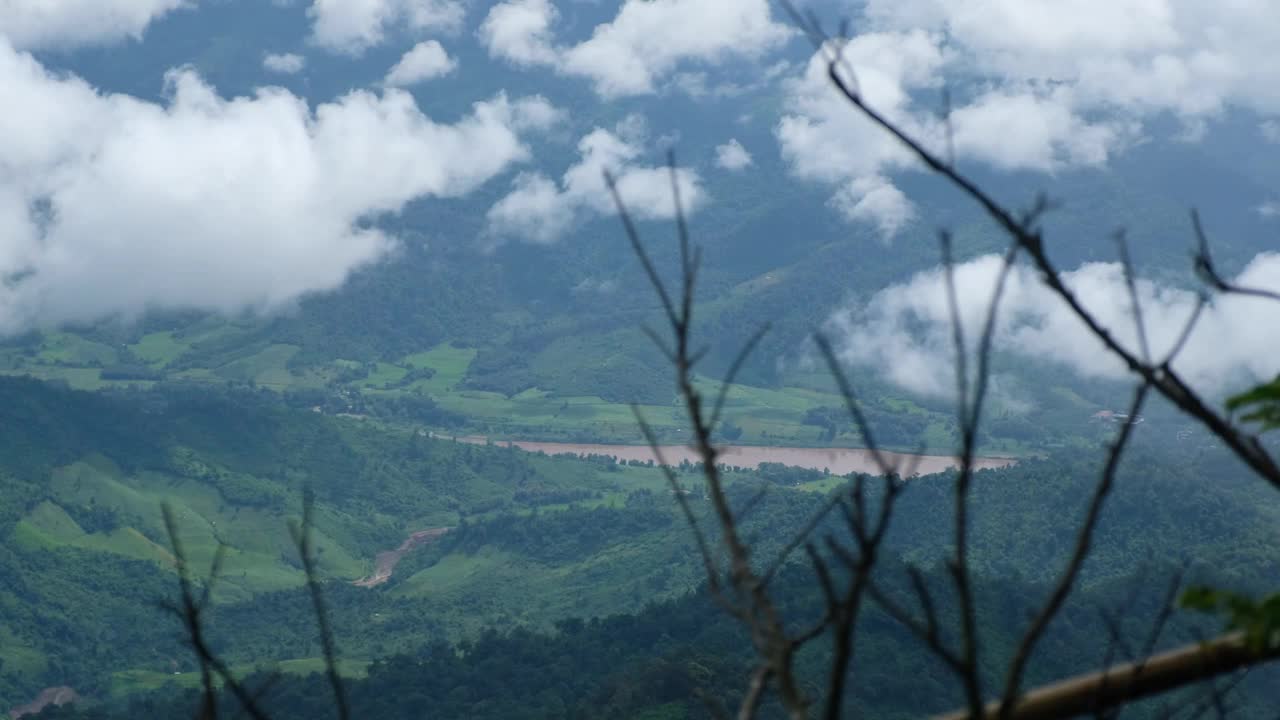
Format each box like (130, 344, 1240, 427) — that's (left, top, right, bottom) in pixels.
(0, 0, 188, 50)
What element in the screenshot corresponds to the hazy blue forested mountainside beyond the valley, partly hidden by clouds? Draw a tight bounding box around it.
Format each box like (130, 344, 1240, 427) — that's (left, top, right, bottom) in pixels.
(0, 1, 1277, 447)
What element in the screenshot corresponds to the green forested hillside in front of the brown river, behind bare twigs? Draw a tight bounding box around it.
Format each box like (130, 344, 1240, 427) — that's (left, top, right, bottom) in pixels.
(0, 380, 1280, 717)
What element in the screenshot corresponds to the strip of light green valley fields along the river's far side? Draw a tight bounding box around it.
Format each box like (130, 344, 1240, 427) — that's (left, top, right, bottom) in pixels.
(0, 319, 1080, 455)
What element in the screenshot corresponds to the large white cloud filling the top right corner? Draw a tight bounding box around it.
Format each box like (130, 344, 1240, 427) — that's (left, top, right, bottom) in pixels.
(865, 0, 1280, 115)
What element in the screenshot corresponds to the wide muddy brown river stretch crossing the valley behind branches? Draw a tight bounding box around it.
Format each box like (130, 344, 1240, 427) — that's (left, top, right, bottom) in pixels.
(457, 436, 1016, 475)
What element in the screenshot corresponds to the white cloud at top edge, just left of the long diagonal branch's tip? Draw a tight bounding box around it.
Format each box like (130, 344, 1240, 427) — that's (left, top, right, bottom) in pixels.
(480, 0, 791, 97)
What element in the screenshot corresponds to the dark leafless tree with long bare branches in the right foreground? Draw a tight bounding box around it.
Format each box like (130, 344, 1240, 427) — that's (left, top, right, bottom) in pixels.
(605, 3, 1280, 720)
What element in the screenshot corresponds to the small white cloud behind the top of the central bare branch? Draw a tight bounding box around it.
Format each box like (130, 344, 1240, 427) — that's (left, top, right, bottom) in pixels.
(486, 120, 705, 243)
